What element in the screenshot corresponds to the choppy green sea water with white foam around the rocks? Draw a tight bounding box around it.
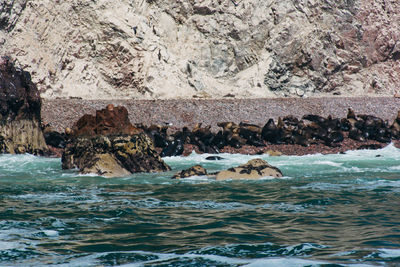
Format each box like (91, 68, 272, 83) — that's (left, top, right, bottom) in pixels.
(0, 145, 400, 267)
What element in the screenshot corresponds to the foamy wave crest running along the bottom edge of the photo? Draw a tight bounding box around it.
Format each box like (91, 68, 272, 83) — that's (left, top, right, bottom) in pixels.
(0, 247, 377, 267)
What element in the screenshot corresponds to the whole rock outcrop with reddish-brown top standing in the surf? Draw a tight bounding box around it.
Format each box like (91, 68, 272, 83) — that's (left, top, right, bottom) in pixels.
(62, 105, 170, 177)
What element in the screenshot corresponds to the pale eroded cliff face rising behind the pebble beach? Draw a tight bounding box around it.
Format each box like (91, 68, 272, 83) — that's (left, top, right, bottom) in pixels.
(0, 0, 400, 99)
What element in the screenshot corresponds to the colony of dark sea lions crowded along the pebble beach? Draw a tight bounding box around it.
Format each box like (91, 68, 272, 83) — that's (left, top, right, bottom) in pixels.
(45, 108, 400, 157)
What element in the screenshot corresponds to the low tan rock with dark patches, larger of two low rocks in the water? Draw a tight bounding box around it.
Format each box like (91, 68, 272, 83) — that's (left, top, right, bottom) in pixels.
(216, 159, 283, 180)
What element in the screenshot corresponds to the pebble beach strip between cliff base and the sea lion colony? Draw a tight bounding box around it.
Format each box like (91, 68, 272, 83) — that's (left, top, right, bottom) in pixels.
(42, 97, 400, 131)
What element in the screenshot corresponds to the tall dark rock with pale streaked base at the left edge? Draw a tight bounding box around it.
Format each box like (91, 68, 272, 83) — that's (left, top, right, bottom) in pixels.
(0, 57, 48, 155)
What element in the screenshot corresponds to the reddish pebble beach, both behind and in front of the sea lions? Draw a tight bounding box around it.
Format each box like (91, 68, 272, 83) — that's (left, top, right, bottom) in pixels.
(42, 97, 400, 155)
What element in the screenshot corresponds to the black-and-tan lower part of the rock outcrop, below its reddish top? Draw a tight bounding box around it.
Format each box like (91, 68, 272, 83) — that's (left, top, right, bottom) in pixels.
(62, 133, 170, 177)
